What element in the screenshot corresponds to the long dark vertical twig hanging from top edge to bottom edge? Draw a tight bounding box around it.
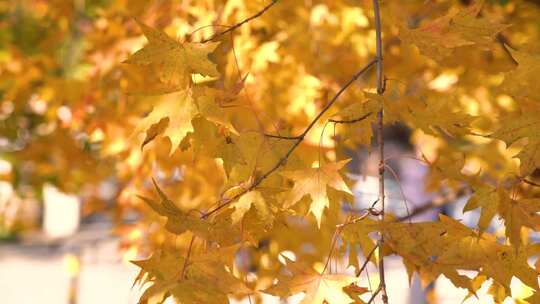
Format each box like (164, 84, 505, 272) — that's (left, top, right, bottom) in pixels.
(368, 0, 388, 304)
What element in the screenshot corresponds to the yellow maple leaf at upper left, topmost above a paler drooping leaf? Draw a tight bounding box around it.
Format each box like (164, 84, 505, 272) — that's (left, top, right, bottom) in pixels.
(125, 20, 219, 89)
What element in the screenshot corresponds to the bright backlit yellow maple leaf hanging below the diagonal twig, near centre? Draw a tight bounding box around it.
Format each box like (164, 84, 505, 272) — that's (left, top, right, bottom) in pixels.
(281, 160, 352, 227)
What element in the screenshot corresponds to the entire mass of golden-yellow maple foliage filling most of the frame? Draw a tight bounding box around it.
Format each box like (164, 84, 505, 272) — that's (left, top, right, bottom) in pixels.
(0, 0, 540, 304)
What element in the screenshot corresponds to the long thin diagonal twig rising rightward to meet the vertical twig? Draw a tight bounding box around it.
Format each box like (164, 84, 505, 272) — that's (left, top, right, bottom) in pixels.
(201, 59, 377, 219)
